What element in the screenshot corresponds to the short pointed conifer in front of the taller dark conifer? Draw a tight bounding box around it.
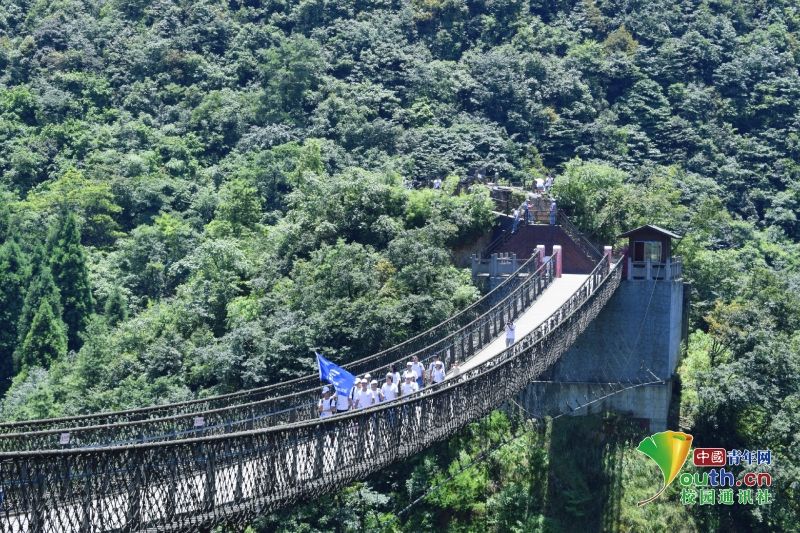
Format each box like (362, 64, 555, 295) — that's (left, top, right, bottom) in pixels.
(17, 298, 67, 368)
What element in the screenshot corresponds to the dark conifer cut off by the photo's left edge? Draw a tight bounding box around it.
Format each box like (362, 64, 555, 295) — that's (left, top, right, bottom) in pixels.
(0, 239, 29, 395)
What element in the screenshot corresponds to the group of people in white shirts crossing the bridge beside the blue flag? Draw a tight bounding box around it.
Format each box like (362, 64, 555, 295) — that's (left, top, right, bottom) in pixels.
(317, 355, 458, 418)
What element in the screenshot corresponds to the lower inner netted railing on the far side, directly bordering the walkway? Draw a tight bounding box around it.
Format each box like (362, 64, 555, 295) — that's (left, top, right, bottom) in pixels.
(0, 258, 555, 451)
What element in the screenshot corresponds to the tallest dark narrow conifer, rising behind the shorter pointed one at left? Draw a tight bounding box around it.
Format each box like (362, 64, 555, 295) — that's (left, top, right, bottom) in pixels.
(47, 213, 94, 350)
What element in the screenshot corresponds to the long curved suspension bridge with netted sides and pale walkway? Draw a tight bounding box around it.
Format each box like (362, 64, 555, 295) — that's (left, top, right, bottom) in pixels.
(0, 198, 684, 533)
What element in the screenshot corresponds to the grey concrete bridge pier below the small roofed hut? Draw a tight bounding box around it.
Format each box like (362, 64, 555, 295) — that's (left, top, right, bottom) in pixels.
(517, 268, 688, 432)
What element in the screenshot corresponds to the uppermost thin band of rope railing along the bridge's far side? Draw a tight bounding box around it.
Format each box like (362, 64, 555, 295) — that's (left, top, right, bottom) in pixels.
(0, 239, 552, 435)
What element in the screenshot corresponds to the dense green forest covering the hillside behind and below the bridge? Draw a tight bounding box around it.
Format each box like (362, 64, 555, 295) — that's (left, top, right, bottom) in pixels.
(0, 0, 800, 532)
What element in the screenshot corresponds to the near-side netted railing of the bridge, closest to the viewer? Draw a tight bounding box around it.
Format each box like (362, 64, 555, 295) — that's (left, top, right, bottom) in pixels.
(0, 260, 621, 533)
